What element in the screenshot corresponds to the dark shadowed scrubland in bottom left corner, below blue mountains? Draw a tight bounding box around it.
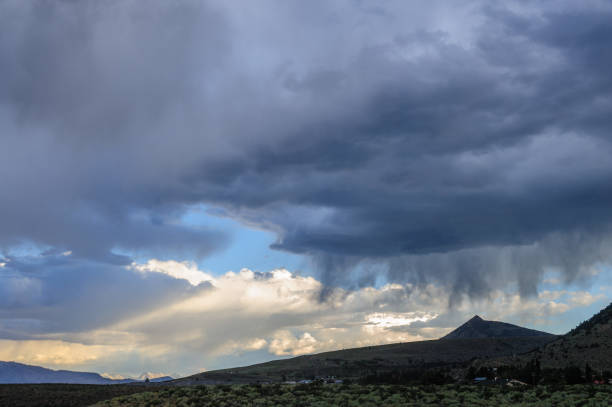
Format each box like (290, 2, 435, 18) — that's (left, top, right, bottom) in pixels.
(0, 384, 170, 407)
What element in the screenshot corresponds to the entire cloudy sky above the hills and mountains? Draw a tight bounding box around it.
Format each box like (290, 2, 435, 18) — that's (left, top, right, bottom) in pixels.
(0, 0, 612, 377)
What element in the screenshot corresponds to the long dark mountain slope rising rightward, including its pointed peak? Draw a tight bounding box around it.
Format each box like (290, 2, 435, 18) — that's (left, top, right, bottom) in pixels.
(172, 317, 556, 385)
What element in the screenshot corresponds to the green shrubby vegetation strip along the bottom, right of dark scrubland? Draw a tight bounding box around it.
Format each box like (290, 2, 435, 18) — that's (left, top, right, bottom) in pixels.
(96, 384, 612, 407)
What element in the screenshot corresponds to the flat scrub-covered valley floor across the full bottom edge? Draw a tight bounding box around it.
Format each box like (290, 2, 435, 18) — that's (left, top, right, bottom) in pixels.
(0, 384, 612, 407)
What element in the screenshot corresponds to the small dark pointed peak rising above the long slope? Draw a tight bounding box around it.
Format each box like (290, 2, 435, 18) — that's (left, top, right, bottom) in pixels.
(441, 315, 554, 339)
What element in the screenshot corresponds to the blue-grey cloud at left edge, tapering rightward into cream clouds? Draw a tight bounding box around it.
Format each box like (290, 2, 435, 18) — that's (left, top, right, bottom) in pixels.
(0, 254, 210, 339)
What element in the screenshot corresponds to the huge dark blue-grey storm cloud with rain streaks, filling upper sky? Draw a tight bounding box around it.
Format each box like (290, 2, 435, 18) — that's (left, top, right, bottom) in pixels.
(0, 2, 612, 302)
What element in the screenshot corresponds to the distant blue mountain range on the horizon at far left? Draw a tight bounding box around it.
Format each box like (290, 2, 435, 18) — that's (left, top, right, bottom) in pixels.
(0, 362, 172, 384)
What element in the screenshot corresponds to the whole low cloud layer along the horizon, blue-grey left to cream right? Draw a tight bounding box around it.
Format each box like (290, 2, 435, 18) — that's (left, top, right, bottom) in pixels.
(0, 259, 606, 376)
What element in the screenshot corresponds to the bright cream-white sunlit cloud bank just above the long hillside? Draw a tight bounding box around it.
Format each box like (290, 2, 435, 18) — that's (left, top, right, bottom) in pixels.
(114, 261, 604, 356)
